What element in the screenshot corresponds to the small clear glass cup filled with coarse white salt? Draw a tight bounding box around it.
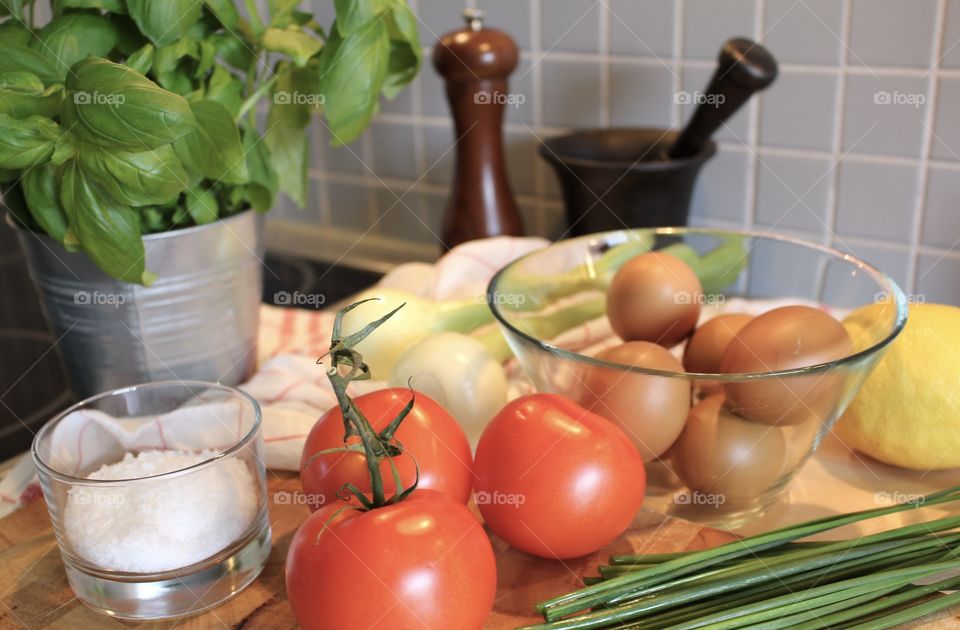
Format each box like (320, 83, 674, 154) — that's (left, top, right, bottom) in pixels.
(32, 381, 271, 620)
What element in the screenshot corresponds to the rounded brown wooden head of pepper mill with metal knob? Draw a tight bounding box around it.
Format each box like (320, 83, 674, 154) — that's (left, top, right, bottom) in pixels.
(433, 9, 519, 82)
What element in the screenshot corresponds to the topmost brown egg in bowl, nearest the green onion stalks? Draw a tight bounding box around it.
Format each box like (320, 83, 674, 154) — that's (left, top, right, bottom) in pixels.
(607, 252, 703, 348)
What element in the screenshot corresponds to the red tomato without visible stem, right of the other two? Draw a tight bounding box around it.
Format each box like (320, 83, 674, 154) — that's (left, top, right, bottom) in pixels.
(474, 394, 646, 559)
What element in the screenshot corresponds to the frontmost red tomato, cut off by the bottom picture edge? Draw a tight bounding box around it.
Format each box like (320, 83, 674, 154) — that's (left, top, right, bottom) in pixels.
(286, 490, 497, 630)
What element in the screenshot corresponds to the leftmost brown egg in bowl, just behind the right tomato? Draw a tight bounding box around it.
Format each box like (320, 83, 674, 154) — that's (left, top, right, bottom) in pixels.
(579, 341, 690, 462)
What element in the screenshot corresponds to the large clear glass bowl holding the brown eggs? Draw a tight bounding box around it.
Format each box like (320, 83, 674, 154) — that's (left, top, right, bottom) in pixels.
(487, 228, 907, 528)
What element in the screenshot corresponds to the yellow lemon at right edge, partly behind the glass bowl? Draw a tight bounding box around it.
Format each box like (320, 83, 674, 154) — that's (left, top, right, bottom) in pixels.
(835, 303, 960, 470)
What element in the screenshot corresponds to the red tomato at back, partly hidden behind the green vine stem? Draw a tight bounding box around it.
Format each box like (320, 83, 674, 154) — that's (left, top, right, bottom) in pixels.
(300, 387, 473, 510)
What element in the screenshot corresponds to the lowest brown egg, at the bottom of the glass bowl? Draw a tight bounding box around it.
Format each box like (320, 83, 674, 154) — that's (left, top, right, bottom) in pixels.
(670, 394, 787, 504)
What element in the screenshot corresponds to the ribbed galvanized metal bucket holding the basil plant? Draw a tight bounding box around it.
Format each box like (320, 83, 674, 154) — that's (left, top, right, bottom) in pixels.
(18, 210, 264, 398)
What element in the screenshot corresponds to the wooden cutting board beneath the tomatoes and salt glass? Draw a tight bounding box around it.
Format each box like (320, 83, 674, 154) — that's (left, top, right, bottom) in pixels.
(0, 472, 732, 630)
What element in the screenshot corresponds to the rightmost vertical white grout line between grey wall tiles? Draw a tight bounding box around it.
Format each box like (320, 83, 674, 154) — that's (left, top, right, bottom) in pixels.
(907, 0, 947, 293)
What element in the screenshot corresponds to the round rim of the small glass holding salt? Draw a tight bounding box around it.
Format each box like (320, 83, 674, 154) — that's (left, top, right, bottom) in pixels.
(30, 380, 263, 487)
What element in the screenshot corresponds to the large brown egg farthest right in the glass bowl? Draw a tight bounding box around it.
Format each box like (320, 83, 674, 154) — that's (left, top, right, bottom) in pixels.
(720, 306, 853, 425)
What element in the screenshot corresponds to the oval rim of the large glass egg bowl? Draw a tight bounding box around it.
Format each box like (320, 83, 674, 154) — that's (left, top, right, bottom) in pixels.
(486, 226, 908, 382)
